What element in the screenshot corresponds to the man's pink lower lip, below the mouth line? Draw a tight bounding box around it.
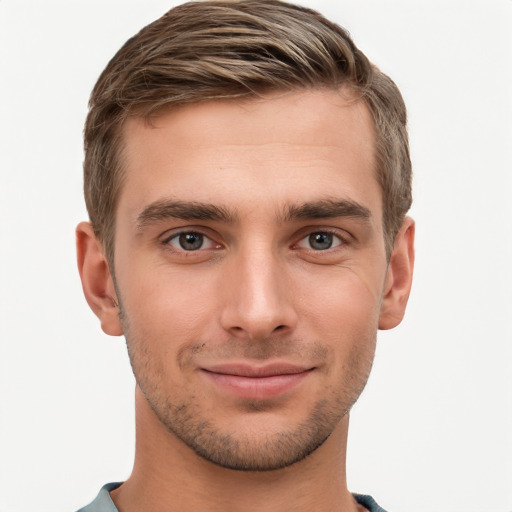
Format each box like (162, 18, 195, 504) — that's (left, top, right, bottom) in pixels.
(203, 370, 312, 400)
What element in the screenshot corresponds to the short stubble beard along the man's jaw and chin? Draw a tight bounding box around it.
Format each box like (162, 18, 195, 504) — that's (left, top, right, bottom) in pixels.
(121, 302, 374, 472)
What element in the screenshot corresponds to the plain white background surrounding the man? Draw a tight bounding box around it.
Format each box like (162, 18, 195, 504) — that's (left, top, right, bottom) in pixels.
(0, 0, 512, 512)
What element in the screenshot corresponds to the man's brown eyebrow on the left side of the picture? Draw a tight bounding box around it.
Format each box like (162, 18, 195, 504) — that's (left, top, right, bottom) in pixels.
(136, 200, 238, 229)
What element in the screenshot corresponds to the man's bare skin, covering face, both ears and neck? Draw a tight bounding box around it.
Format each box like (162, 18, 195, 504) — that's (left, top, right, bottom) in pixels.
(77, 90, 414, 512)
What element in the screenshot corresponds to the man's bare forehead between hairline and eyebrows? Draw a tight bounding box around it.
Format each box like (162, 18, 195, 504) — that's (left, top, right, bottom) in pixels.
(119, 90, 380, 222)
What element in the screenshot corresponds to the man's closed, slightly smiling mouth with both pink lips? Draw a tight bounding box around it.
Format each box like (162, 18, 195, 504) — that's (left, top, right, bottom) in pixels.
(201, 363, 315, 400)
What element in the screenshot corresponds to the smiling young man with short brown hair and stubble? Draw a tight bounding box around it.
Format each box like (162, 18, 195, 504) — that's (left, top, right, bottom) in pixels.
(77, 0, 414, 512)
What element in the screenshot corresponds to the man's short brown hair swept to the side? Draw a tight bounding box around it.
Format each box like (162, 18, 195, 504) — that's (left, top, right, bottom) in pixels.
(84, 0, 412, 264)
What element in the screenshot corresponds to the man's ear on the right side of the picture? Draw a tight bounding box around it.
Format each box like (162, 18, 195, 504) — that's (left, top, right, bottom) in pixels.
(379, 217, 414, 329)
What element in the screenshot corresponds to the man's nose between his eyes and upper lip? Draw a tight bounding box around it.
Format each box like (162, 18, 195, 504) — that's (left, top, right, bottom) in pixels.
(221, 245, 298, 340)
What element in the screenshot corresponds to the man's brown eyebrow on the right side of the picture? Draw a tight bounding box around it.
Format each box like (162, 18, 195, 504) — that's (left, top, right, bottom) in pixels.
(284, 199, 372, 222)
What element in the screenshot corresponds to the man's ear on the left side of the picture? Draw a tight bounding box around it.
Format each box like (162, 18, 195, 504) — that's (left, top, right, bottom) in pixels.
(76, 222, 123, 336)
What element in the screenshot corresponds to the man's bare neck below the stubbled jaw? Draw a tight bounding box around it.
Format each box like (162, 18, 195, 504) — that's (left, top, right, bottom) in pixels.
(111, 388, 357, 512)
